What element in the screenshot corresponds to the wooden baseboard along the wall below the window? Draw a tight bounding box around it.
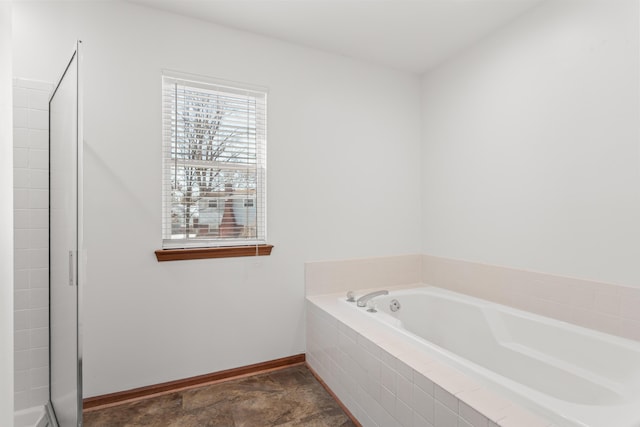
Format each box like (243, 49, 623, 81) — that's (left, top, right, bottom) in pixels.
(82, 353, 304, 411)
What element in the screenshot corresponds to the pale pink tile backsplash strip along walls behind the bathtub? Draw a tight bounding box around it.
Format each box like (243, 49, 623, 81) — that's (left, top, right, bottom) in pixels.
(305, 255, 640, 341)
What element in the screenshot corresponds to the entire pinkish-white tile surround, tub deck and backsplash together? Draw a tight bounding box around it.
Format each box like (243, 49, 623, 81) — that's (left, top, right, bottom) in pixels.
(305, 255, 640, 427)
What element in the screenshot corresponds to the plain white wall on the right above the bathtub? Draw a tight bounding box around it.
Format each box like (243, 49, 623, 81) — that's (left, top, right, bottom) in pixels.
(422, 0, 640, 286)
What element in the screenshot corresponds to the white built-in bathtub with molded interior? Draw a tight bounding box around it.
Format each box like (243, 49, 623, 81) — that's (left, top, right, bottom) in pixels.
(341, 287, 640, 427)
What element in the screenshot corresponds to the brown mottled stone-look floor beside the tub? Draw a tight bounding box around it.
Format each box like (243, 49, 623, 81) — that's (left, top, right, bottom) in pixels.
(84, 365, 354, 427)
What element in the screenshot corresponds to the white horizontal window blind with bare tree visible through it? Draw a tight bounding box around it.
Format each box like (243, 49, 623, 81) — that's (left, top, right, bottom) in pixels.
(162, 72, 267, 248)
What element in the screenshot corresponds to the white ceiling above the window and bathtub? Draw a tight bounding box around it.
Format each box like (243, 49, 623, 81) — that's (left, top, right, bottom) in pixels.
(129, 0, 541, 73)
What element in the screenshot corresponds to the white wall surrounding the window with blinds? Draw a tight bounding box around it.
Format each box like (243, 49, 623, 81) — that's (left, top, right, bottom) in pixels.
(14, 2, 420, 396)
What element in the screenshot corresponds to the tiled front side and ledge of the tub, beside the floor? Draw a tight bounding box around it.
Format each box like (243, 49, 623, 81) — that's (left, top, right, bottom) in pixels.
(307, 294, 553, 427)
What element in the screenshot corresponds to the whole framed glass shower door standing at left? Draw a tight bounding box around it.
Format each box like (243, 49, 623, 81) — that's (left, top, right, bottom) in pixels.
(47, 42, 83, 427)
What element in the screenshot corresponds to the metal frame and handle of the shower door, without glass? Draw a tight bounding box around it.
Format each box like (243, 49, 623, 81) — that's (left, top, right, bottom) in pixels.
(45, 40, 86, 427)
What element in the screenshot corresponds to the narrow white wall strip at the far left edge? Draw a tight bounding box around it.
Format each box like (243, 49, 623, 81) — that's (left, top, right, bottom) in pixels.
(0, 2, 13, 426)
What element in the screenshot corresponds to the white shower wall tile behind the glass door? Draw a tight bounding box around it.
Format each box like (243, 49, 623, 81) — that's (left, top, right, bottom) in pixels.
(13, 79, 53, 411)
